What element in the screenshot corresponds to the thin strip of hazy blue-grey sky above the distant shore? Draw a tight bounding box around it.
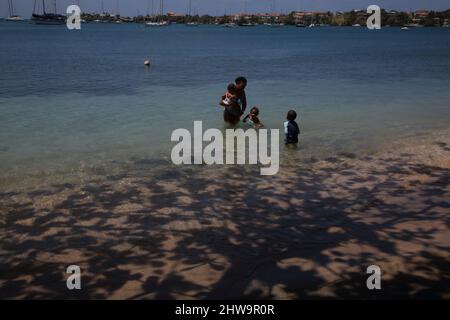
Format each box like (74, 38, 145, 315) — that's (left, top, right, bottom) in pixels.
(0, 0, 450, 18)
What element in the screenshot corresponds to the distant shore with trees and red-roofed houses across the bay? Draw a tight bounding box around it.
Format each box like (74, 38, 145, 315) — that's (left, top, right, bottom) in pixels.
(3, 9, 450, 27)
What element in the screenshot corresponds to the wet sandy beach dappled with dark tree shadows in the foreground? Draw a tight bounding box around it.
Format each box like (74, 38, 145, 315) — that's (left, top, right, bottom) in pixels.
(0, 134, 450, 299)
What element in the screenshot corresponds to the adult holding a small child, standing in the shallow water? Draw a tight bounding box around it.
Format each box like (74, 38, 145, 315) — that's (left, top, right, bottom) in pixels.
(220, 77, 247, 126)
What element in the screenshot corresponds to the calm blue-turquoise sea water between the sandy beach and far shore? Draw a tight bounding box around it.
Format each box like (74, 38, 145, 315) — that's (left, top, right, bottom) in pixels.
(0, 22, 450, 185)
